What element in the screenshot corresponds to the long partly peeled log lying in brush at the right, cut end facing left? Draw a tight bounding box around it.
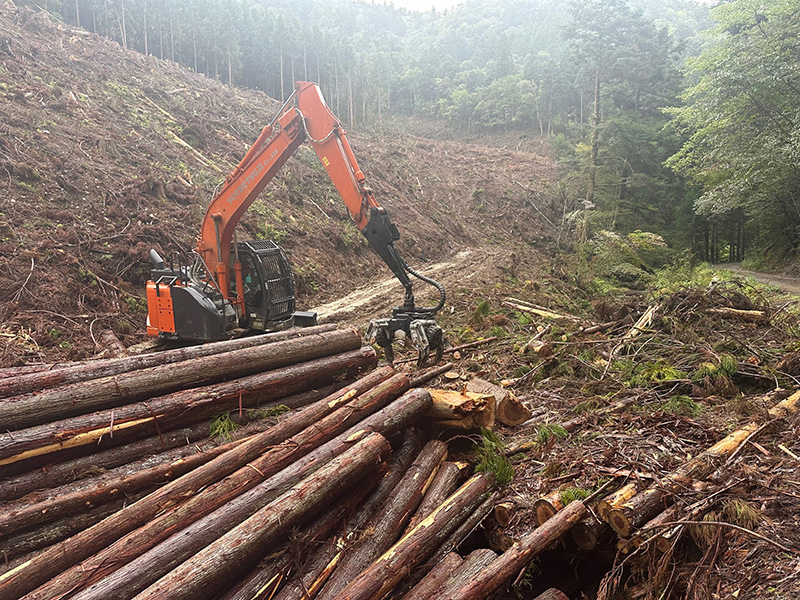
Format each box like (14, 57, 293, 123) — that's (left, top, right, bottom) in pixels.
(608, 392, 800, 537)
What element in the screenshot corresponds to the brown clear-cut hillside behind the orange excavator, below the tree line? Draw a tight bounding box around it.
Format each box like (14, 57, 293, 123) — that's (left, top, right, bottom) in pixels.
(0, 4, 552, 364)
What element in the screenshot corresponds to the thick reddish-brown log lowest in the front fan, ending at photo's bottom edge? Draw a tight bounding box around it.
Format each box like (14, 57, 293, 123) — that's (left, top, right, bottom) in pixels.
(134, 434, 390, 600)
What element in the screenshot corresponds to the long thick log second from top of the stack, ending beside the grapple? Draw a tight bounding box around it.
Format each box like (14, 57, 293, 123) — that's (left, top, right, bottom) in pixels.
(0, 329, 361, 429)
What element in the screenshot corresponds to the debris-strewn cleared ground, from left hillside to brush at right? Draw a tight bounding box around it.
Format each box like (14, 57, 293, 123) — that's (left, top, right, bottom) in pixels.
(0, 4, 800, 600)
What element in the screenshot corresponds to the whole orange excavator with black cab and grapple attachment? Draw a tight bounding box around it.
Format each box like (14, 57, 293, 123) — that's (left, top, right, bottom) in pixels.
(147, 82, 445, 364)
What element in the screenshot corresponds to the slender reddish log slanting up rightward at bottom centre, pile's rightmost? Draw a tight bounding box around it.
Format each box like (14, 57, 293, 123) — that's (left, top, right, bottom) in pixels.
(444, 501, 588, 600)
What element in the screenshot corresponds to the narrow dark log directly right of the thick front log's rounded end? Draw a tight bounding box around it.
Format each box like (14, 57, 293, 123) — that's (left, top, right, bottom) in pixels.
(274, 430, 422, 600)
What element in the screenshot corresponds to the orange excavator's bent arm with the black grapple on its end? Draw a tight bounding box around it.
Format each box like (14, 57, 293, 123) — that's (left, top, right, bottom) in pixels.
(150, 82, 445, 361)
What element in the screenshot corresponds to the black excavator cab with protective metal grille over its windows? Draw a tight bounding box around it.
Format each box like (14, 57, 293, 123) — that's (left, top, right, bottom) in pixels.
(231, 240, 295, 331)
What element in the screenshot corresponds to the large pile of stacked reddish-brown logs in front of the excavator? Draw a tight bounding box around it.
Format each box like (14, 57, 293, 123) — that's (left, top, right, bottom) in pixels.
(0, 327, 570, 600)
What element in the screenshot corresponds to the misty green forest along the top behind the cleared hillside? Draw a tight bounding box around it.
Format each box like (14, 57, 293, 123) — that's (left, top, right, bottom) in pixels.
(17, 0, 800, 259)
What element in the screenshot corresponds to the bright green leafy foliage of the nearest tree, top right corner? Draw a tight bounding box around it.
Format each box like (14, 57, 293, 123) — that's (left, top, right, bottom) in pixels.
(667, 0, 800, 256)
